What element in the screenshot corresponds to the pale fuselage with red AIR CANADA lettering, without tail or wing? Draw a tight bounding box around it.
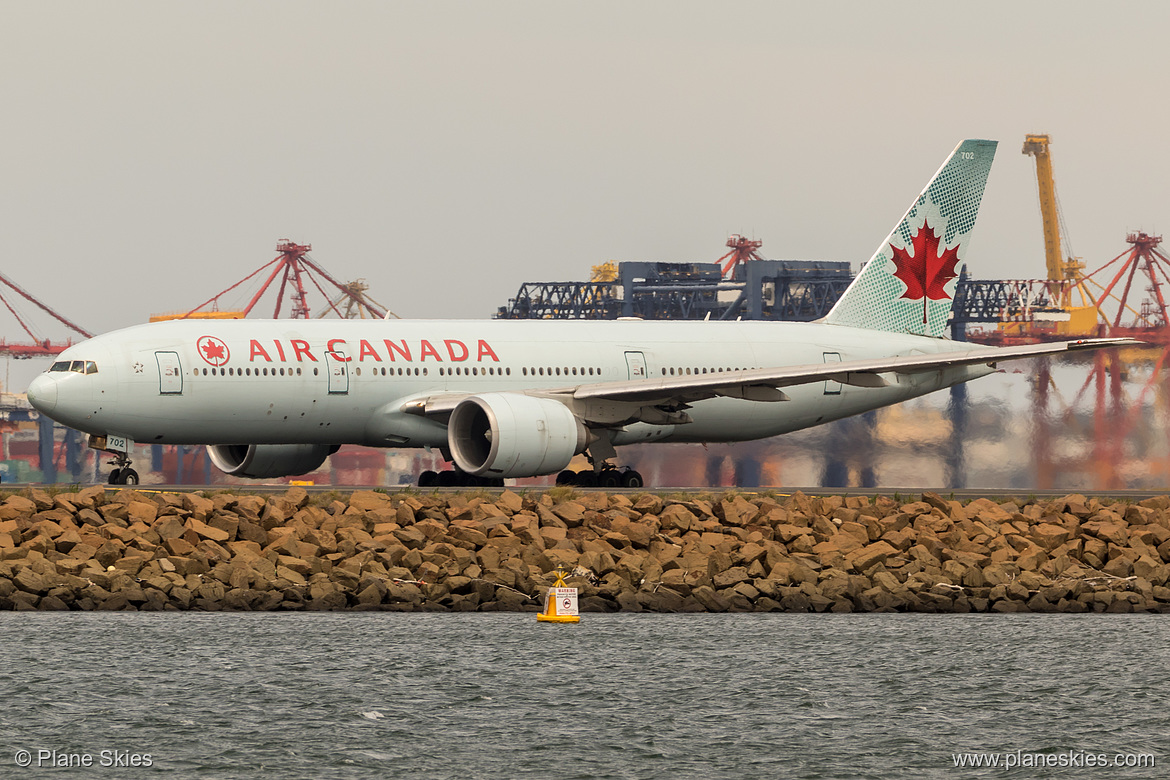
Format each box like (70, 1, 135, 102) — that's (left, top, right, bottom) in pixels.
(29, 319, 993, 447)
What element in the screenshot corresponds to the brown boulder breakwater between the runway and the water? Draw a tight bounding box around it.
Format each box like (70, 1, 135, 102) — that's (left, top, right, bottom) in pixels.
(0, 486, 1170, 612)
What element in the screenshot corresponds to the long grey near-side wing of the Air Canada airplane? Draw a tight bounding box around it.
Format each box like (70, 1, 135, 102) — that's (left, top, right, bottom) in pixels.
(401, 338, 1143, 417)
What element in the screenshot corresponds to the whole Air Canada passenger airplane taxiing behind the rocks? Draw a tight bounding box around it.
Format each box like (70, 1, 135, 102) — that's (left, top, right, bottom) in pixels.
(28, 140, 1135, 488)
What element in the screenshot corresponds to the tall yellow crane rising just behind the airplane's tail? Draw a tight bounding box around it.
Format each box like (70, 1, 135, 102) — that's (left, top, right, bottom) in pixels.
(1021, 133, 1097, 336)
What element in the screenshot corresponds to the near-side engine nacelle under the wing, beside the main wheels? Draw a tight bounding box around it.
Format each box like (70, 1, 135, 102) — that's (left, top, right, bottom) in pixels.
(447, 393, 589, 477)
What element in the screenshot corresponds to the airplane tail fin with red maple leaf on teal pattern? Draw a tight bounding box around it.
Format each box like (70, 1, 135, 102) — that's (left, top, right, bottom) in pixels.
(823, 140, 997, 338)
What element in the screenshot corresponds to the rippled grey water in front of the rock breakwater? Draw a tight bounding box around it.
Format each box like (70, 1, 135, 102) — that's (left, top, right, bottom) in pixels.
(0, 613, 1170, 780)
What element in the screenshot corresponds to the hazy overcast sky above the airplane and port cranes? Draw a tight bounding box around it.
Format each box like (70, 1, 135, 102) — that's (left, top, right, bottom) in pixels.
(0, 0, 1170, 364)
